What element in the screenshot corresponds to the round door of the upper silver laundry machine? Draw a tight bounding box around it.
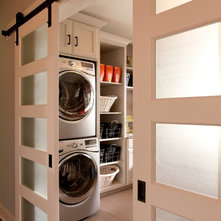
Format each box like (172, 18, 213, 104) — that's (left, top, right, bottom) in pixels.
(59, 70, 94, 121)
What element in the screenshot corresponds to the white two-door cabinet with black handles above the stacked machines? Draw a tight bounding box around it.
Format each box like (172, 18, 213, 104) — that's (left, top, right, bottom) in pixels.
(60, 19, 98, 59)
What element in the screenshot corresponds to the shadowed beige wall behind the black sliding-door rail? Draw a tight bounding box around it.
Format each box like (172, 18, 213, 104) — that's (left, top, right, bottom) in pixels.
(0, 0, 34, 214)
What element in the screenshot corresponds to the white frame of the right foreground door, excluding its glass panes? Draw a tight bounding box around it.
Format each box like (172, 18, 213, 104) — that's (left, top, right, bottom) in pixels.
(133, 0, 221, 221)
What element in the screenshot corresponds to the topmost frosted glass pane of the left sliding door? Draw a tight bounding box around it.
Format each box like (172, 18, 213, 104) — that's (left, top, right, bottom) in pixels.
(21, 24, 48, 65)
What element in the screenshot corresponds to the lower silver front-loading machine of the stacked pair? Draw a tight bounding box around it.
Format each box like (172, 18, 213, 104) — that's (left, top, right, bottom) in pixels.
(59, 138, 100, 221)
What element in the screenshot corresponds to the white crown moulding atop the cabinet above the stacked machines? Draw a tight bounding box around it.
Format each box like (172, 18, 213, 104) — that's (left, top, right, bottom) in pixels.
(70, 12, 108, 29)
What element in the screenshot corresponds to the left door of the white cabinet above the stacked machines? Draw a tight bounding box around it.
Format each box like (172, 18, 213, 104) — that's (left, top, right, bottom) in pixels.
(60, 19, 73, 54)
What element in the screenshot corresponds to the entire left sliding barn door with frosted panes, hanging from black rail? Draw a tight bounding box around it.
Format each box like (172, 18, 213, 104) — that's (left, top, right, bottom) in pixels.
(15, 3, 59, 221)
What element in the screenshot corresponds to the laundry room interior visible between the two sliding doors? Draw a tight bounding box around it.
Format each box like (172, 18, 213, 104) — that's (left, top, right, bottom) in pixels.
(59, 0, 133, 221)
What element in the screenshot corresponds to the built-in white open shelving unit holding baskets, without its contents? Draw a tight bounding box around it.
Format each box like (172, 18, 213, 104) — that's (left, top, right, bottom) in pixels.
(100, 33, 133, 194)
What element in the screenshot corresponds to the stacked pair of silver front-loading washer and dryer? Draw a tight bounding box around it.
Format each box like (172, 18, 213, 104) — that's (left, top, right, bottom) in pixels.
(59, 56, 100, 221)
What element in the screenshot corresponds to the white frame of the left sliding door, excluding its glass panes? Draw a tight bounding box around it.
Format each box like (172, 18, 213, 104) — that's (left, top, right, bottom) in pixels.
(15, 3, 59, 221)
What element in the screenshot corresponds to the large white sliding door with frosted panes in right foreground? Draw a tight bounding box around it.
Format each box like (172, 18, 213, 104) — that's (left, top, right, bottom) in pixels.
(133, 0, 221, 221)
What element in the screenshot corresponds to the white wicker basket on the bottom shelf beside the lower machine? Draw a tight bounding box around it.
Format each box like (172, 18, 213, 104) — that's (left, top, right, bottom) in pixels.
(100, 165, 120, 188)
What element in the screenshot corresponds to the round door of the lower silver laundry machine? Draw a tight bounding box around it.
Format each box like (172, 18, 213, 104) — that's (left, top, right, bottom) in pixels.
(59, 152, 98, 205)
